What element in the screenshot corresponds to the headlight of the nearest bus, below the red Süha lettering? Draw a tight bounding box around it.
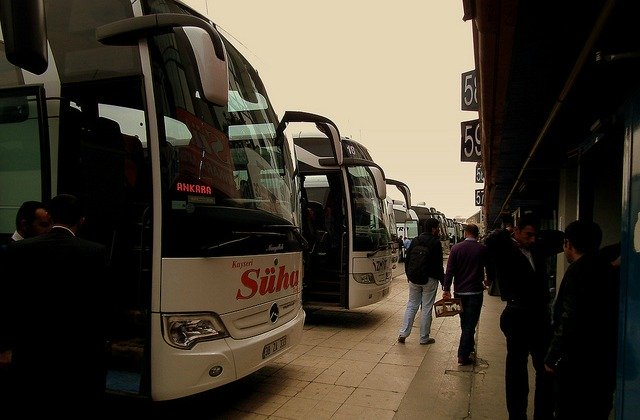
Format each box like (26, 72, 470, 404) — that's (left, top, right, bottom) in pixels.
(162, 313, 229, 349)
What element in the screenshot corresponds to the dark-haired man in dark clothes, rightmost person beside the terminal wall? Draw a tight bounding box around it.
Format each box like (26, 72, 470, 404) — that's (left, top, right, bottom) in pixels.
(545, 220, 618, 420)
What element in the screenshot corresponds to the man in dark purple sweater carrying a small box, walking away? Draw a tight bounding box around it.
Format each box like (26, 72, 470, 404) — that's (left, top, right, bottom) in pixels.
(442, 223, 489, 366)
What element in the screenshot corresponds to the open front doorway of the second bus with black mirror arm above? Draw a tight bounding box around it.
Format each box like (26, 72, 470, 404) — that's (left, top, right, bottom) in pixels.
(274, 111, 349, 307)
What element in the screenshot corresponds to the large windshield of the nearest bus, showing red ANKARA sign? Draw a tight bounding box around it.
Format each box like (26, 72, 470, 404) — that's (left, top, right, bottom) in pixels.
(147, 1, 297, 257)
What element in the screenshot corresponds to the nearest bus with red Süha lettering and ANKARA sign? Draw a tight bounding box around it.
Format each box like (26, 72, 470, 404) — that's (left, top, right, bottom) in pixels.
(0, 0, 316, 401)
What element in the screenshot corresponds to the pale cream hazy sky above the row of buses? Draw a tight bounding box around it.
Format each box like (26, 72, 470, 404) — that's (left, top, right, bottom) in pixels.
(187, 0, 482, 217)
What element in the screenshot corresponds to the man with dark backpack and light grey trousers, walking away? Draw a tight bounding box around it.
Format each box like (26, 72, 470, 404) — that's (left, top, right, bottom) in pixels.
(398, 218, 444, 344)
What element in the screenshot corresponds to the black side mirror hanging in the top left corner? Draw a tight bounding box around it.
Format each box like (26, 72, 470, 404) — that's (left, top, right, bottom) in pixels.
(0, 0, 49, 74)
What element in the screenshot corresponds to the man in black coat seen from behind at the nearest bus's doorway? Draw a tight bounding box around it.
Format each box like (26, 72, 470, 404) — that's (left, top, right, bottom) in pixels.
(4, 194, 107, 414)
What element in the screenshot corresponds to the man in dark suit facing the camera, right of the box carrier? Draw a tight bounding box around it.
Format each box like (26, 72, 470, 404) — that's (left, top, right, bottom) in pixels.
(485, 215, 554, 420)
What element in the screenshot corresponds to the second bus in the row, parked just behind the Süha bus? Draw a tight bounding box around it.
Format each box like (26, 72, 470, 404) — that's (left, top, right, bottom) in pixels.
(294, 125, 408, 309)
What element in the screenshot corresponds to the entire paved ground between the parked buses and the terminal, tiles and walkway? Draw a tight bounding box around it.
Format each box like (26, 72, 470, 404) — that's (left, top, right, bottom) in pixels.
(136, 264, 534, 420)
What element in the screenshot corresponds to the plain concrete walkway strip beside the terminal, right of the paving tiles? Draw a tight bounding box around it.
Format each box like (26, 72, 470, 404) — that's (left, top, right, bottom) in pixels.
(393, 270, 516, 420)
